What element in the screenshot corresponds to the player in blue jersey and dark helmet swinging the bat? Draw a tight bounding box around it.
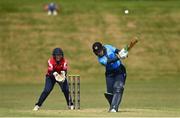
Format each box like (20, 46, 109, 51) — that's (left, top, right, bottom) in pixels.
(92, 42, 128, 112)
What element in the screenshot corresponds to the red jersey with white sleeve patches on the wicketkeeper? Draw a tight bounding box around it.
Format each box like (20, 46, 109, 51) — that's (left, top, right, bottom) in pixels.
(47, 57, 67, 75)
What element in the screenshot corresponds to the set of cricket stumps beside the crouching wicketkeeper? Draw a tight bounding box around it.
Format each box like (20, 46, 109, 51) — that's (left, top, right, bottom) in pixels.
(68, 75, 80, 109)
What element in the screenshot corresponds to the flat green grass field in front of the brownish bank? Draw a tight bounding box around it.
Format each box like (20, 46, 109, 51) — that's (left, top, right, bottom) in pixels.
(0, 74, 180, 117)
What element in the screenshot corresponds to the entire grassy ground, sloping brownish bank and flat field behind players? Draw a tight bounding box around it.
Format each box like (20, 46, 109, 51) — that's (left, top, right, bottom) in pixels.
(0, 0, 180, 116)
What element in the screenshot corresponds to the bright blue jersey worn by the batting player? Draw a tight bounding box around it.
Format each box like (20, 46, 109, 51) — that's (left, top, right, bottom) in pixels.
(98, 45, 121, 71)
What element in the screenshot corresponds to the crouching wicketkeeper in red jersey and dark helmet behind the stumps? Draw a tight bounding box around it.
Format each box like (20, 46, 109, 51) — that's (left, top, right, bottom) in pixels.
(33, 48, 73, 111)
